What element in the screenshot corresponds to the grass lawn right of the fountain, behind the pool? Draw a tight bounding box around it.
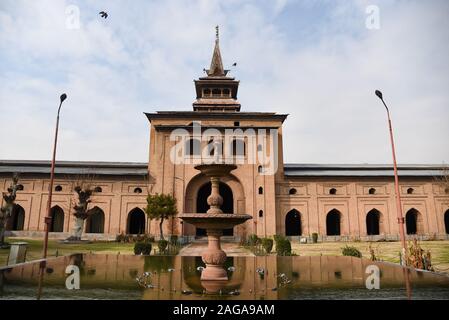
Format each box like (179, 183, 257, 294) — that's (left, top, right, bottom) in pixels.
(292, 241, 449, 273)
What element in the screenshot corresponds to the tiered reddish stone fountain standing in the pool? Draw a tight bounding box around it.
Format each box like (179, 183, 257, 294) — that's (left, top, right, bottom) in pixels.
(180, 164, 252, 286)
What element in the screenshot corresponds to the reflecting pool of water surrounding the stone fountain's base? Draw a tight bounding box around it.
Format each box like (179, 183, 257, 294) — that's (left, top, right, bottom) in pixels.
(0, 254, 449, 300)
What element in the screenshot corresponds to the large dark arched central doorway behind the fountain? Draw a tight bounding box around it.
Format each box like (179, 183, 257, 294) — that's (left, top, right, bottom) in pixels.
(196, 182, 234, 236)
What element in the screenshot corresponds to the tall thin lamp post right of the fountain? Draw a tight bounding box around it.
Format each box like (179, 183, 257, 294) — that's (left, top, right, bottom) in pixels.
(375, 90, 407, 265)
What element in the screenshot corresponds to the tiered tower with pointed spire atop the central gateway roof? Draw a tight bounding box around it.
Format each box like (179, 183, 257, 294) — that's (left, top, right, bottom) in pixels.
(193, 26, 240, 112)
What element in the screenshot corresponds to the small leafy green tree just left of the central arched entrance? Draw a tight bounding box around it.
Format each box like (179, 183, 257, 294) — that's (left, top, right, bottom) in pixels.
(145, 193, 178, 240)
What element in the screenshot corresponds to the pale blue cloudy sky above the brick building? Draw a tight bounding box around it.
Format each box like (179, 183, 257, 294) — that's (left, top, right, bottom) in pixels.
(0, 0, 449, 164)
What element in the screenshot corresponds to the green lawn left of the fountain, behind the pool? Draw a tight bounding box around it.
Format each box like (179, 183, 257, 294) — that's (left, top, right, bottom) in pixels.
(0, 238, 134, 266)
